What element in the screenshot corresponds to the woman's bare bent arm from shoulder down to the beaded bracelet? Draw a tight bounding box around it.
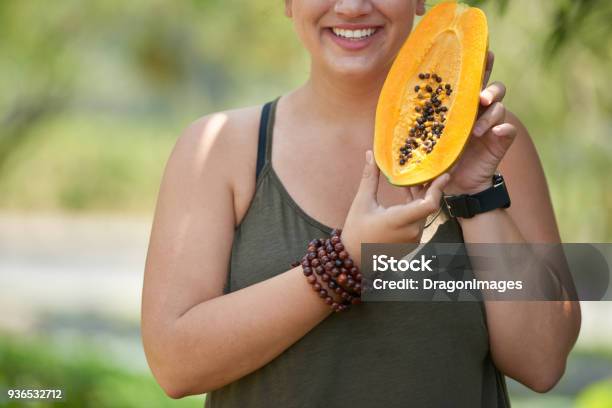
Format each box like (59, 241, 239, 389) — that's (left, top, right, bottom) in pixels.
(142, 114, 330, 398)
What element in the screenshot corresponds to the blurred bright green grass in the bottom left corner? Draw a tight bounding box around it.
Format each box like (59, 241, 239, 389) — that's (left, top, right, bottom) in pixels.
(0, 336, 203, 408)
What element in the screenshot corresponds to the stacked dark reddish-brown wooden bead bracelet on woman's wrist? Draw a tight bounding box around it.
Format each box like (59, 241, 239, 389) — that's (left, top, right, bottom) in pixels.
(292, 229, 362, 312)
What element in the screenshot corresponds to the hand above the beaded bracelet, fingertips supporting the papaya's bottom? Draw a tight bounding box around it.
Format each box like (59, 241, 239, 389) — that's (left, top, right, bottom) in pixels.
(342, 150, 450, 266)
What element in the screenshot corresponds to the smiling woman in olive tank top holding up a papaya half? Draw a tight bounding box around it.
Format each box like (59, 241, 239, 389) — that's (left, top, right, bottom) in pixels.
(142, 0, 579, 407)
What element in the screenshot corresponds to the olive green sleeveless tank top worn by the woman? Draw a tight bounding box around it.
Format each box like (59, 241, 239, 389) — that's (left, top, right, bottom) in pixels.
(206, 101, 510, 408)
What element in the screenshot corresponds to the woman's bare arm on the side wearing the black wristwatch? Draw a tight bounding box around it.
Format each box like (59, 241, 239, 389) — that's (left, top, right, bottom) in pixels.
(461, 113, 580, 392)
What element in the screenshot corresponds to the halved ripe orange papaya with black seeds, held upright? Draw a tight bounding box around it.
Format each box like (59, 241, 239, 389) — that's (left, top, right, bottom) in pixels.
(374, 2, 488, 186)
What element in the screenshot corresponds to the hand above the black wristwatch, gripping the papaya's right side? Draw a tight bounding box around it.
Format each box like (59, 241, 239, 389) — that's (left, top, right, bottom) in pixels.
(444, 53, 517, 194)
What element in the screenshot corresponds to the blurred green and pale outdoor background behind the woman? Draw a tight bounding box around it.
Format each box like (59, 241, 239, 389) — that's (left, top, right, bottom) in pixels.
(0, 0, 612, 408)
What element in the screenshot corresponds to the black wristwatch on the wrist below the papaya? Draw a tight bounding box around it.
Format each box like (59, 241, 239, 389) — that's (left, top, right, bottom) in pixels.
(444, 174, 510, 218)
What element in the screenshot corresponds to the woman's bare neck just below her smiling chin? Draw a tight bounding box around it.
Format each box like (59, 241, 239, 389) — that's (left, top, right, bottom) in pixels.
(301, 59, 386, 123)
